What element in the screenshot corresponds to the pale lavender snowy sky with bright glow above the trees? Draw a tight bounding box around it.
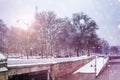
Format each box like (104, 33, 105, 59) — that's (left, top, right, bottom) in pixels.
(0, 0, 120, 45)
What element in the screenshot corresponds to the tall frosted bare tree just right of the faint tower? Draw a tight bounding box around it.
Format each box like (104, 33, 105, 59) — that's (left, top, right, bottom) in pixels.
(34, 11, 63, 56)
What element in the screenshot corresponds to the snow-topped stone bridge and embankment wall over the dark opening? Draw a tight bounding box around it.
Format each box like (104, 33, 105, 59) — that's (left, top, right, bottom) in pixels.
(0, 56, 93, 80)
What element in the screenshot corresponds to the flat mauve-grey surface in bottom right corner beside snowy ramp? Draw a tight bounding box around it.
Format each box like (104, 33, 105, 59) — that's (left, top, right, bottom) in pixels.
(97, 60, 120, 80)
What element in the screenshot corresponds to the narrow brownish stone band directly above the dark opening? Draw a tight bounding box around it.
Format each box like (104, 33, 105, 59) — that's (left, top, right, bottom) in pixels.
(8, 64, 50, 76)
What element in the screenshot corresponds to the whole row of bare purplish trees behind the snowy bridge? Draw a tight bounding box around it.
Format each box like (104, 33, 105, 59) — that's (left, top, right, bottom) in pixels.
(0, 11, 113, 57)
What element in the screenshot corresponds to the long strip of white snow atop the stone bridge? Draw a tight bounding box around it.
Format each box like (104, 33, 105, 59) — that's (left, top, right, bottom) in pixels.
(7, 55, 89, 67)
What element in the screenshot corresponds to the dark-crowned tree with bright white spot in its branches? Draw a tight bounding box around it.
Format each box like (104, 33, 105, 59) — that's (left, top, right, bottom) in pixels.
(73, 13, 98, 56)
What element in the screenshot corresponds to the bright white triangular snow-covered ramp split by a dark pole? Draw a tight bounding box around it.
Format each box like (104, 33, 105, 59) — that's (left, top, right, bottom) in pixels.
(73, 57, 108, 76)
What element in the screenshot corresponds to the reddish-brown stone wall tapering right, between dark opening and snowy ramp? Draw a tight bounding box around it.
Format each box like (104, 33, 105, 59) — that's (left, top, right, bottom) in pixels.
(51, 57, 93, 80)
